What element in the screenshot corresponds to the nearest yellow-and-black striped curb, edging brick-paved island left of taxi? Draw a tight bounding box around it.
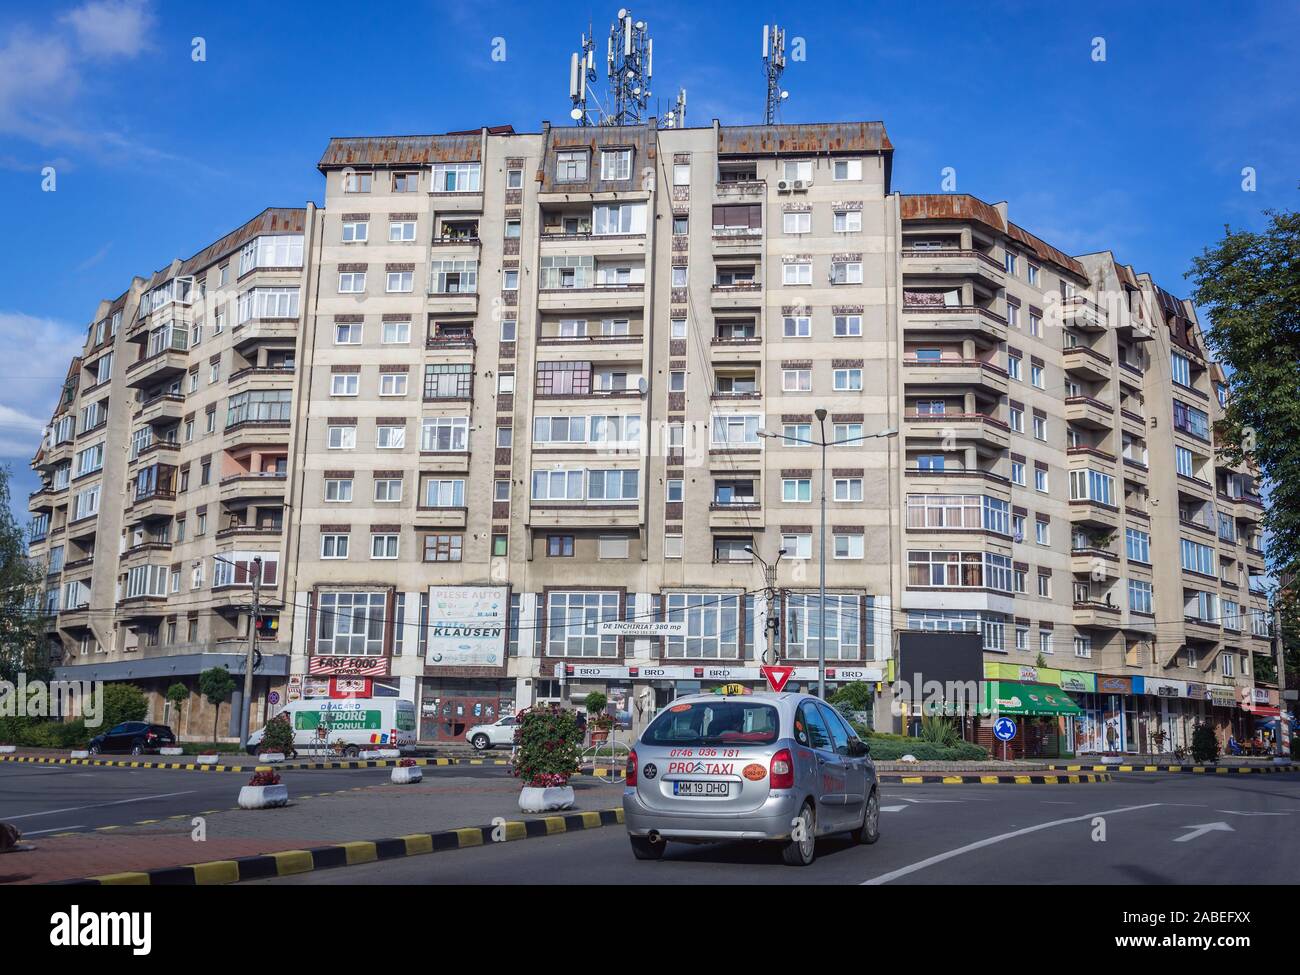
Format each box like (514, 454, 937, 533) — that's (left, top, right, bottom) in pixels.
(55, 809, 623, 887)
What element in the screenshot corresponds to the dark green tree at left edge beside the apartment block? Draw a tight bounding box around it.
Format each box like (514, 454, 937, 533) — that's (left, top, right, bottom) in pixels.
(0, 467, 53, 683)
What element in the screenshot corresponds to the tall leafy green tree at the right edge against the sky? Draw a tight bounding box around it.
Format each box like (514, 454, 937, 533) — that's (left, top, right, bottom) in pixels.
(1188, 211, 1300, 587)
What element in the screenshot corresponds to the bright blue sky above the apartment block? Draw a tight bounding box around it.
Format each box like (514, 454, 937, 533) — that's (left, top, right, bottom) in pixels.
(0, 0, 1300, 519)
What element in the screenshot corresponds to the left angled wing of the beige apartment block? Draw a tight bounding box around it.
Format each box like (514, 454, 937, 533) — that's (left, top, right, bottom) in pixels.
(29, 207, 315, 737)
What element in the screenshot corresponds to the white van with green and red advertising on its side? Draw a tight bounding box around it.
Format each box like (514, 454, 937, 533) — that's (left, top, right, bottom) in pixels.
(248, 697, 415, 758)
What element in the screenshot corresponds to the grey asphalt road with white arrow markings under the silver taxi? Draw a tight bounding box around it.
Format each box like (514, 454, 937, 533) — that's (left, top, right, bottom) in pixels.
(259, 774, 1300, 884)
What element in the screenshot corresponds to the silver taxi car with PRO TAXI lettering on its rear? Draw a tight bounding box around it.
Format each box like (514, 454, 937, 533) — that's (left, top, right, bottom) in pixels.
(623, 693, 880, 866)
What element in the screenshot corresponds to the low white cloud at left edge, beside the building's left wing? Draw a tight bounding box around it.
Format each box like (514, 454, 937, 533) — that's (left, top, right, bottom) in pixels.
(0, 311, 85, 467)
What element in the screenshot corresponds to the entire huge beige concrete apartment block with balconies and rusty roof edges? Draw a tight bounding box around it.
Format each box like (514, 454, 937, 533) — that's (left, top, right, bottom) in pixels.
(25, 121, 1275, 754)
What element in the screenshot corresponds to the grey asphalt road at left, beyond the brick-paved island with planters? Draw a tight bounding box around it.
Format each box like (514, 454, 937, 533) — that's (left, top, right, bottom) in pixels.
(0, 762, 499, 839)
